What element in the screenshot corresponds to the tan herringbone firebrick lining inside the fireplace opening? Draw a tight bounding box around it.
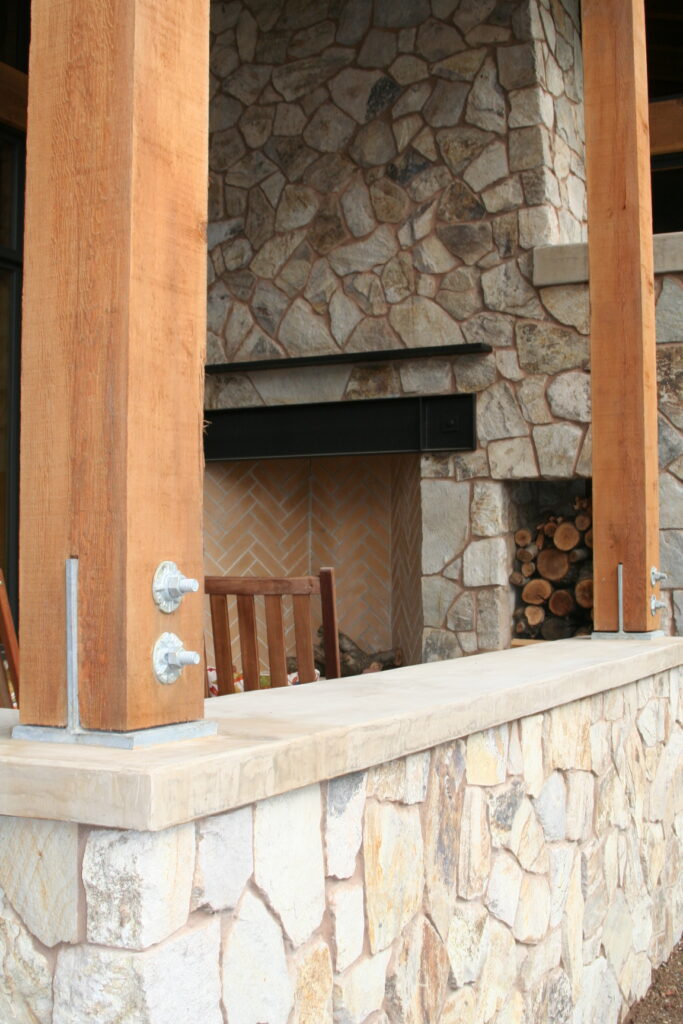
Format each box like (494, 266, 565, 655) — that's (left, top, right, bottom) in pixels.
(204, 457, 420, 667)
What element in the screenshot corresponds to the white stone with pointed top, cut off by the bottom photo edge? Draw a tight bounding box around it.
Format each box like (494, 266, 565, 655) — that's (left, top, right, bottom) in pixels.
(222, 890, 294, 1024)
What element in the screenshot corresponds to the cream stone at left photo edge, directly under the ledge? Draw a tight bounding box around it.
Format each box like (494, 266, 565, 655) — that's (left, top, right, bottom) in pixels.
(0, 815, 80, 946)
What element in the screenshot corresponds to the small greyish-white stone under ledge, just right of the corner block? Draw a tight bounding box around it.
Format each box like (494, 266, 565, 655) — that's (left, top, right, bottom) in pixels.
(193, 807, 254, 910)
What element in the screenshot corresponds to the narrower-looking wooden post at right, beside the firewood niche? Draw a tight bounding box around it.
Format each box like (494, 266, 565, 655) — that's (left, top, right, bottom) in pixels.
(583, 0, 658, 632)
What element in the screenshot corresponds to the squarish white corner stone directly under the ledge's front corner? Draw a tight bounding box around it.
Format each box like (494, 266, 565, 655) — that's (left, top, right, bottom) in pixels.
(83, 824, 195, 949)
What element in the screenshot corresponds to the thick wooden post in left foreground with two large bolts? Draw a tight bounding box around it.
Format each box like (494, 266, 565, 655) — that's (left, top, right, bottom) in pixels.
(19, 0, 209, 730)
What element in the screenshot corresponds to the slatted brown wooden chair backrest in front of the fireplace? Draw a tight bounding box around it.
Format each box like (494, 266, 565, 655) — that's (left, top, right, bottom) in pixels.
(204, 568, 341, 693)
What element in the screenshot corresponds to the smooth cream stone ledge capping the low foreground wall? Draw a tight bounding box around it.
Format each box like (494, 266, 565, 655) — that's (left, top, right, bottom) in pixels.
(0, 637, 683, 831)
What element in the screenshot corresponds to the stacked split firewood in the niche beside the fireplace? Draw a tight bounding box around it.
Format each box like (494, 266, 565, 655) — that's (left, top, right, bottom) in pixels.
(510, 498, 593, 640)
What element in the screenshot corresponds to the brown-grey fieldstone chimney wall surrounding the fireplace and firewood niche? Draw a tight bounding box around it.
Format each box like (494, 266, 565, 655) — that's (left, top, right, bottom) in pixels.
(206, 0, 683, 660)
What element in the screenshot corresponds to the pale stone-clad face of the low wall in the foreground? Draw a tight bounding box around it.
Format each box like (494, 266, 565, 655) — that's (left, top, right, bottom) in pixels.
(0, 668, 683, 1024)
